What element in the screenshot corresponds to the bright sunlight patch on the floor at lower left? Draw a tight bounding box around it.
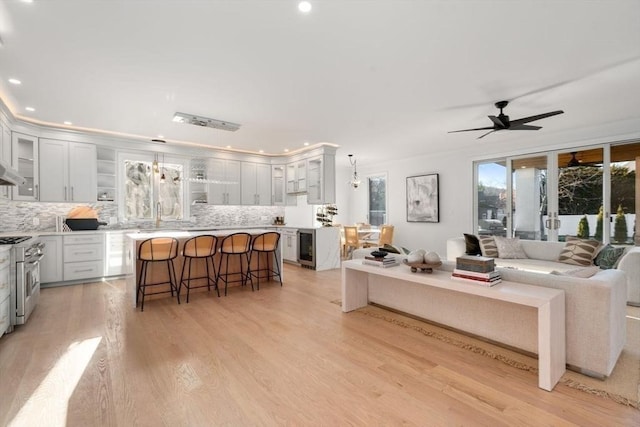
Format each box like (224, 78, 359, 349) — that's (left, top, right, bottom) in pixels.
(9, 337, 102, 427)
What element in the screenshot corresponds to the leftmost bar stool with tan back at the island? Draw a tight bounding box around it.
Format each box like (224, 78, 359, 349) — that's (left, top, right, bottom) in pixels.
(136, 237, 180, 311)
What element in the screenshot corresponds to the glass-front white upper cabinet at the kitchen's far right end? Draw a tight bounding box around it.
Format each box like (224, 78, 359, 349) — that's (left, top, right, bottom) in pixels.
(307, 154, 336, 205)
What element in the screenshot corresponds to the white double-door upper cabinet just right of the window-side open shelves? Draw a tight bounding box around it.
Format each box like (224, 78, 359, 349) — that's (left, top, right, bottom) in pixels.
(207, 159, 241, 205)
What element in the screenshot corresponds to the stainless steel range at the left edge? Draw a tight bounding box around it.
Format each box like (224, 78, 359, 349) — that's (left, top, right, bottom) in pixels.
(0, 236, 44, 331)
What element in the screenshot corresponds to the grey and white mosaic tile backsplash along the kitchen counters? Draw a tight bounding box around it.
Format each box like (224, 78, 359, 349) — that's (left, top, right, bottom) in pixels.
(0, 200, 284, 233)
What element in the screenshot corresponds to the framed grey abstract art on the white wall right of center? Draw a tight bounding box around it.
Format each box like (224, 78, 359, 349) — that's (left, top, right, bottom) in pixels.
(407, 173, 440, 222)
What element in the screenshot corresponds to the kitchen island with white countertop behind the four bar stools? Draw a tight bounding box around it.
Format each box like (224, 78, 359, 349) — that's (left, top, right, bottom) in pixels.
(126, 228, 284, 306)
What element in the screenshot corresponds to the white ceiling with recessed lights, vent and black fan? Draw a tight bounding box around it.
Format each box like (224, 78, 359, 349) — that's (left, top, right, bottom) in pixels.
(0, 0, 640, 164)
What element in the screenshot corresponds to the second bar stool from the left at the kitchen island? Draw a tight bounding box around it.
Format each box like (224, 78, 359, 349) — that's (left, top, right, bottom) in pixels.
(178, 234, 220, 304)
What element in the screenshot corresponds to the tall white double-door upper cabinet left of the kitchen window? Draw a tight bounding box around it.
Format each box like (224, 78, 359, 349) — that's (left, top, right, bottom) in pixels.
(40, 138, 97, 202)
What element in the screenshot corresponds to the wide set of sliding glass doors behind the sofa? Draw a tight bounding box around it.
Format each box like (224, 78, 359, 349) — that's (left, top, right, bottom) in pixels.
(474, 142, 640, 245)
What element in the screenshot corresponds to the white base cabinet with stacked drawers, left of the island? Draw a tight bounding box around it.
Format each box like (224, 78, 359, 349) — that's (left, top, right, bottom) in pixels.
(62, 233, 104, 281)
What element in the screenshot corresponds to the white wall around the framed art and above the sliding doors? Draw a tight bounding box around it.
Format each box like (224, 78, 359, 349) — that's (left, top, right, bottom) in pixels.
(336, 124, 640, 257)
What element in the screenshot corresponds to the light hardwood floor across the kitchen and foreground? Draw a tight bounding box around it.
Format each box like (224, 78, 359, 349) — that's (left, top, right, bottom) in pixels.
(0, 266, 640, 426)
